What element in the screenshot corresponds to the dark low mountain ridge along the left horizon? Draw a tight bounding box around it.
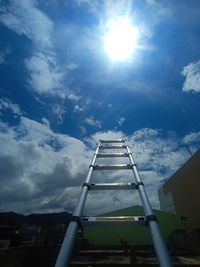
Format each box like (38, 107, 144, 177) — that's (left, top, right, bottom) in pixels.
(0, 212, 72, 226)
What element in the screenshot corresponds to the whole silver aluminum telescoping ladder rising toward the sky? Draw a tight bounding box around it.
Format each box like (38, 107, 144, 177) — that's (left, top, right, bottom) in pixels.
(55, 139, 173, 267)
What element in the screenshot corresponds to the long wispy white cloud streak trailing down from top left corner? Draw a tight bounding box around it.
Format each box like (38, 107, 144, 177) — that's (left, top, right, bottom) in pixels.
(0, 0, 83, 101)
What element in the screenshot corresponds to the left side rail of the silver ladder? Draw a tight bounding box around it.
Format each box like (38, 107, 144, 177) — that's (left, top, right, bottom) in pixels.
(55, 141, 101, 267)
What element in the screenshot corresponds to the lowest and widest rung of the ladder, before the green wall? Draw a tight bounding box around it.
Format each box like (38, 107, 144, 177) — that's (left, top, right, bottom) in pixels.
(81, 216, 146, 226)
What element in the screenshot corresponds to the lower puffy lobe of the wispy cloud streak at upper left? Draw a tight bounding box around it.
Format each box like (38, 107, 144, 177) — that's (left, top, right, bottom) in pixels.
(25, 53, 65, 98)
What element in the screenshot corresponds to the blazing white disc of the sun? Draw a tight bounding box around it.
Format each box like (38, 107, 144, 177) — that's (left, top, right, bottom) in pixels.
(103, 17, 139, 61)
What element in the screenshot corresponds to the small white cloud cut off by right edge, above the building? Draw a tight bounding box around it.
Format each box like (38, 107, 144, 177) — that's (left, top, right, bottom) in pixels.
(181, 60, 200, 93)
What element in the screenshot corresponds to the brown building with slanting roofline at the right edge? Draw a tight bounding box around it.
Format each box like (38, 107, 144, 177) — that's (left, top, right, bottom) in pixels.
(158, 150, 200, 232)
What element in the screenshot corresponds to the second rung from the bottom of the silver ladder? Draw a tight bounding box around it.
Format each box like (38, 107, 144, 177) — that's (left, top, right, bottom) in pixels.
(90, 183, 137, 190)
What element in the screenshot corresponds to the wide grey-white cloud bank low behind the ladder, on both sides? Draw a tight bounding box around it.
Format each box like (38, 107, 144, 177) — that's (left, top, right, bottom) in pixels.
(0, 120, 198, 214)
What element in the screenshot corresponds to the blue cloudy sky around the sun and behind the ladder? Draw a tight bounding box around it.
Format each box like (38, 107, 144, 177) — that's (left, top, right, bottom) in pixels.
(0, 0, 200, 216)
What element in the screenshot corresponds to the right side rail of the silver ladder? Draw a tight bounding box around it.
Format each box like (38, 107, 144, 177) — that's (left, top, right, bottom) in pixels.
(125, 141, 173, 267)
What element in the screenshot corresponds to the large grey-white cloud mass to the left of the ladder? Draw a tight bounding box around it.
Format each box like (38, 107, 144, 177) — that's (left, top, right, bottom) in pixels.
(0, 117, 91, 215)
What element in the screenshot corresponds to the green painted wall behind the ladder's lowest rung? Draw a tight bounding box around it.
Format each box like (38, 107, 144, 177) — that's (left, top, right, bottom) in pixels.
(83, 206, 185, 246)
